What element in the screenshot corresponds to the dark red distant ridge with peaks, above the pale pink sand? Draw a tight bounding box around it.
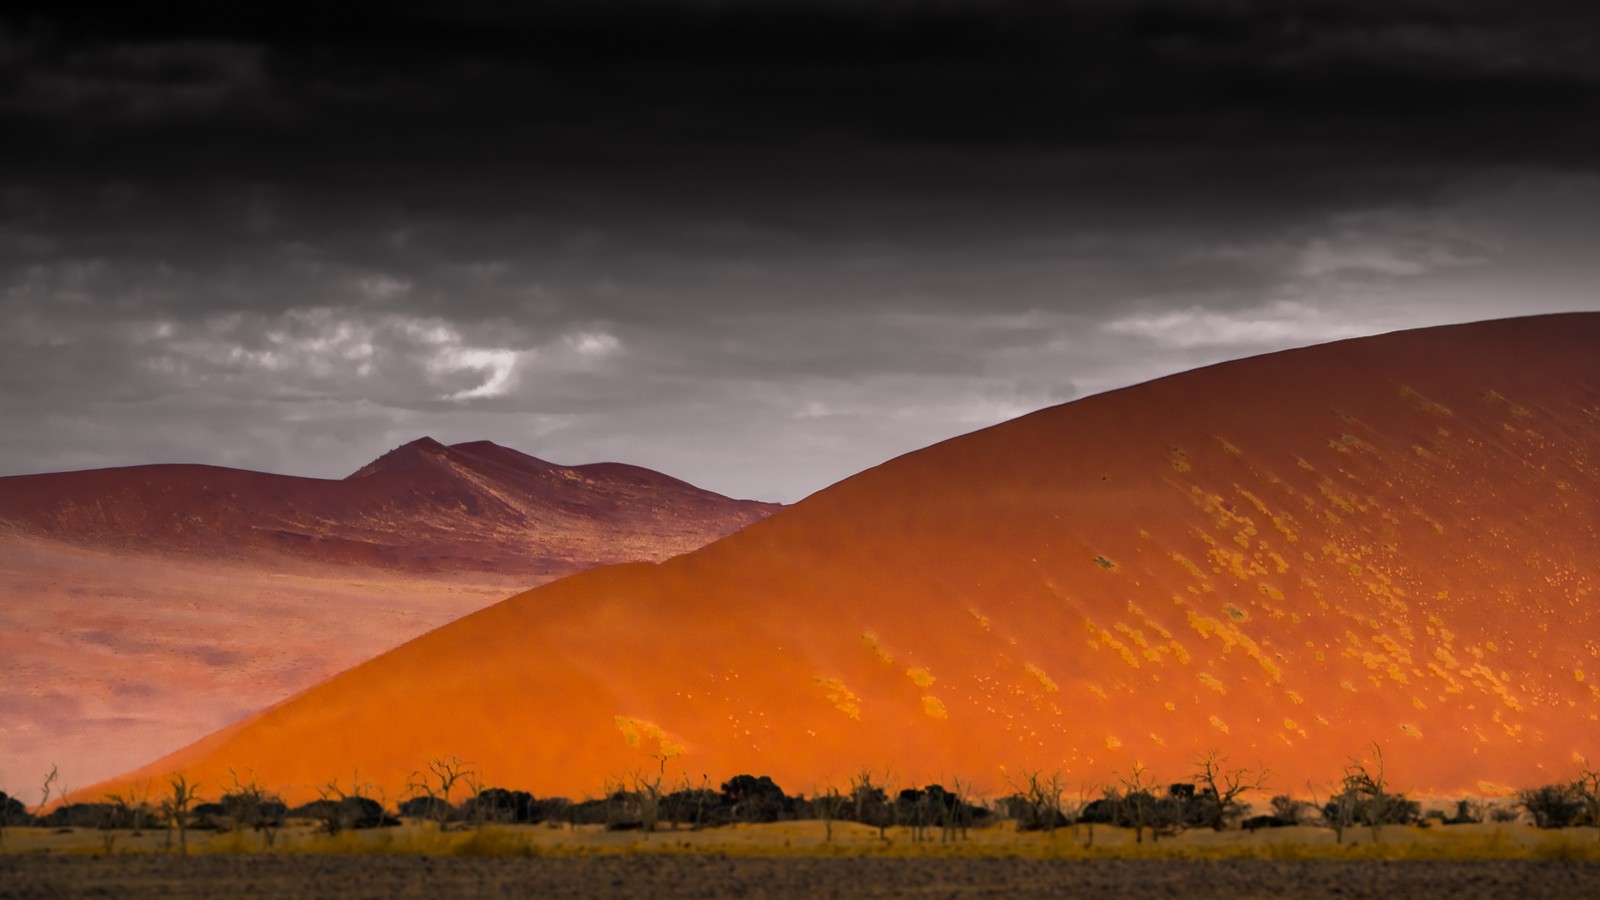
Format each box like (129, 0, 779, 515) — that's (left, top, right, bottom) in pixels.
(0, 437, 778, 583)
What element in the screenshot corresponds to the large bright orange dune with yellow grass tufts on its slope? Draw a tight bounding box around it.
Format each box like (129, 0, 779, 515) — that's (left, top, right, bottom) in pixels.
(96, 314, 1600, 796)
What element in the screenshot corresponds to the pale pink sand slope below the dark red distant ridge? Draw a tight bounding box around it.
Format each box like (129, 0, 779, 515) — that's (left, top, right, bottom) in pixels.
(0, 535, 528, 801)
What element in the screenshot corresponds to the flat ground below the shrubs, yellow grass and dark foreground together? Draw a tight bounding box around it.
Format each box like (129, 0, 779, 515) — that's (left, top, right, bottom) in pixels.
(0, 822, 1600, 900)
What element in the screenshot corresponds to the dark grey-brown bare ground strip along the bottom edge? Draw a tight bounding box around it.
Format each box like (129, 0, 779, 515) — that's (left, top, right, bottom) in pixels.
(9, 854, 1600, 900)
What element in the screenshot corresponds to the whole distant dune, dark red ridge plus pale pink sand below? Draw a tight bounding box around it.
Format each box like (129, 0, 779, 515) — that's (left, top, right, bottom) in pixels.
(0, 439, 776, 796)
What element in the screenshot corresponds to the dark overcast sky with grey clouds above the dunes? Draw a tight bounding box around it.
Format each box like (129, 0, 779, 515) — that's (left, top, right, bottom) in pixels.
(0, 0, 1600, 501)
